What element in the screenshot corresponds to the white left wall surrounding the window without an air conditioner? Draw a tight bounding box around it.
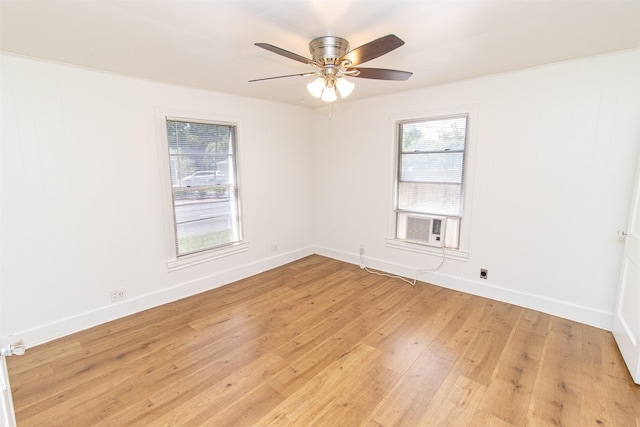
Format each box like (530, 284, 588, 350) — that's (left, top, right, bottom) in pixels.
(0, 55, 313, 346)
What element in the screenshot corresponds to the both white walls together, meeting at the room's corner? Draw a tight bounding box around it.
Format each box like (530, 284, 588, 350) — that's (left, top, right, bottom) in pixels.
(0, 50, 640, 345)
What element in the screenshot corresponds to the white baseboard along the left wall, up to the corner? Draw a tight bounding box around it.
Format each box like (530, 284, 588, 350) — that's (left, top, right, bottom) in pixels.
(5, 247, 314, 347)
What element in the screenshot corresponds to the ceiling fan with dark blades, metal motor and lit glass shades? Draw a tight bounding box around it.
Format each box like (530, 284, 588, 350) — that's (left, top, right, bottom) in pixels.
(249, 34, 413, 102)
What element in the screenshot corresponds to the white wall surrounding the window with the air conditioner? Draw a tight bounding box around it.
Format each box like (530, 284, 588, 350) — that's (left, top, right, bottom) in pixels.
(313, 50, 640, 329)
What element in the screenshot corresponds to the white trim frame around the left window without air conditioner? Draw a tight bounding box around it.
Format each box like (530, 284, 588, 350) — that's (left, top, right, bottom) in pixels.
(154, 107, 249, 271)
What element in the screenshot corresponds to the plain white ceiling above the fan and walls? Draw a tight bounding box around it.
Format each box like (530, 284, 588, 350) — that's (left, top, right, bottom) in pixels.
(0, 0, 640, 107)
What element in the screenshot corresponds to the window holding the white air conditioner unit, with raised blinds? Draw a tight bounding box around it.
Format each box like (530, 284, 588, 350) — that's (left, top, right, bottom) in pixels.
(396, 114, 468, 249)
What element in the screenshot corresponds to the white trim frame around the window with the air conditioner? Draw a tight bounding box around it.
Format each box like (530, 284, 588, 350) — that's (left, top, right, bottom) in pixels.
(385, 104, 479, 261)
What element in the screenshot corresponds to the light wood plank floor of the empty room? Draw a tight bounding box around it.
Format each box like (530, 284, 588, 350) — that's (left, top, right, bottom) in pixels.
(7, 256, 640, 427)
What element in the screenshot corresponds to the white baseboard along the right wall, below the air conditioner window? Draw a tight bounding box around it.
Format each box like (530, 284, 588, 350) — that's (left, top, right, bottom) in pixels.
(315, 247, 613, 331)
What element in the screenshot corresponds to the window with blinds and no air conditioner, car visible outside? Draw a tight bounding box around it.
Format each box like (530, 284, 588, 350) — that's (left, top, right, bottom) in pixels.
(166, 118, 241, 257)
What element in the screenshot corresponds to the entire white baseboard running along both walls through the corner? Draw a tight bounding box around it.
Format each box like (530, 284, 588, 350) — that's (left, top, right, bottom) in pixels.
(5, 247, 613, 347)
